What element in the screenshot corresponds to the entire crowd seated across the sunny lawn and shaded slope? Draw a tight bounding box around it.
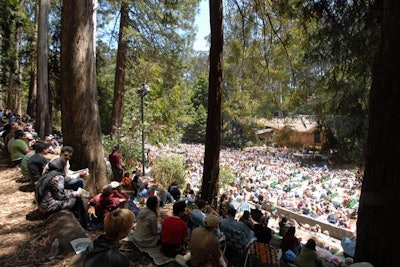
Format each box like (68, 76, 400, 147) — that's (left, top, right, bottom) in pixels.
(1, 110, 368, 267)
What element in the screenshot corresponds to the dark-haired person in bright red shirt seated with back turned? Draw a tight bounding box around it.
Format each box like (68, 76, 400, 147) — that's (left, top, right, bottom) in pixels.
(161, 201, 189, 258)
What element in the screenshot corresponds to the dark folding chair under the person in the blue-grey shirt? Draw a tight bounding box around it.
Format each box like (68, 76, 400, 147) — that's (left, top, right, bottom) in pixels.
(222, 228, 257, 266)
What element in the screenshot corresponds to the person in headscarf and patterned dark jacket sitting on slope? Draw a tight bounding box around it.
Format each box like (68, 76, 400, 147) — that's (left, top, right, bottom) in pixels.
(35, 158, 87, 229)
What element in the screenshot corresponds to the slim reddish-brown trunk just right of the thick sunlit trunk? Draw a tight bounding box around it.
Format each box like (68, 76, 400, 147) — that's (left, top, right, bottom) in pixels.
(111, 1, 129, 137)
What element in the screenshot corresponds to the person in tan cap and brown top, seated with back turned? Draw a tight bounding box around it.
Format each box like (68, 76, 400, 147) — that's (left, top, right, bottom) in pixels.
(181, 214, 228, 267)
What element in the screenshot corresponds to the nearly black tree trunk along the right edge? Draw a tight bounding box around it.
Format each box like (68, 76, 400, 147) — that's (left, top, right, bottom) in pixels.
(355, 0, 400, 266)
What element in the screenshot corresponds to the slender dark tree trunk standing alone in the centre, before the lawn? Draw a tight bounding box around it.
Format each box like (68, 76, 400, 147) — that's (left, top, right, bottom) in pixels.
(201, 0, 224, 205)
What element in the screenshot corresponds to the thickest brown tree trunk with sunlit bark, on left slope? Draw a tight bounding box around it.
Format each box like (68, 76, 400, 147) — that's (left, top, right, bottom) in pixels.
(61, 0, 108, 194)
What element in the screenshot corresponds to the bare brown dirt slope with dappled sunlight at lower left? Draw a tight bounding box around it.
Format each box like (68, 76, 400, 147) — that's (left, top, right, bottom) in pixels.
(0, 151, 160, 267)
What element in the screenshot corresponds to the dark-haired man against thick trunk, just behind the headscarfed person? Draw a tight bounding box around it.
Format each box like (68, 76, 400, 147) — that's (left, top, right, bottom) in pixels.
(44, 146, 88, 191)
